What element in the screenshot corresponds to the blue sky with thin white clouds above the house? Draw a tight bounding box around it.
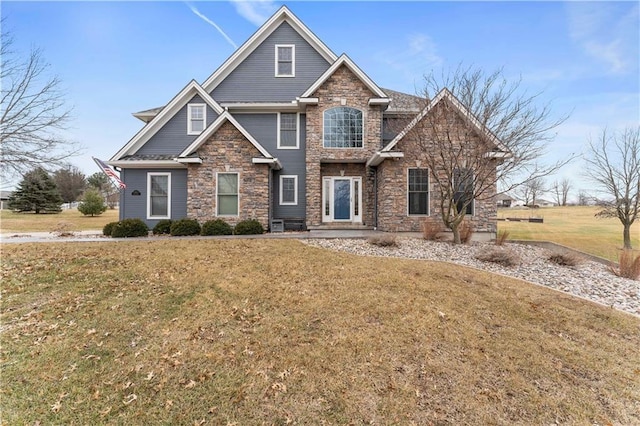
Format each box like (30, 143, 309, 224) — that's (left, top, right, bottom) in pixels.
(0, 0, 640, 196)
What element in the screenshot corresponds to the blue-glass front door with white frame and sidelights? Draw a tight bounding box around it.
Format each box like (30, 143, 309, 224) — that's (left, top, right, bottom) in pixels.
(322, 176, 362, 223)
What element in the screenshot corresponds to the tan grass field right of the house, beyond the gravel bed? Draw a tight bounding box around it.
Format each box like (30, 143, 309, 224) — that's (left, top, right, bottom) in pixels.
(498, 206, 640, 261)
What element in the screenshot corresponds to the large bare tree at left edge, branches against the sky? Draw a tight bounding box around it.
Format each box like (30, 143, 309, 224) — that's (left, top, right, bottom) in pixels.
(0, 20, 80, 177)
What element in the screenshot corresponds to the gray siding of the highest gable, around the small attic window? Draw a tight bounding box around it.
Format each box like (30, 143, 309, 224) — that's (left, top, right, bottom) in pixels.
(211, 22, 330, 102)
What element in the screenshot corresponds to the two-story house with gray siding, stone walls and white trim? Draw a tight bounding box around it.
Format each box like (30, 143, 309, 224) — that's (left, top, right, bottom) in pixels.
(109, 6, 510, 233)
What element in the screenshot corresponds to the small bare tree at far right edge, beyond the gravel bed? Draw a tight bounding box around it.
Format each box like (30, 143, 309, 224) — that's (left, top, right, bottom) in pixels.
(585, 126, 640, 249)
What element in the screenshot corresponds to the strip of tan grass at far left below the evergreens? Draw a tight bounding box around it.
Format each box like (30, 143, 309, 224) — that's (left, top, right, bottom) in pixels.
(0, 209, 118, 234)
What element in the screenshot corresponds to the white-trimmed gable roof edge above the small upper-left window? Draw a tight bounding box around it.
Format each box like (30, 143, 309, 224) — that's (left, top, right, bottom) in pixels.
(109, 80, 224, 161)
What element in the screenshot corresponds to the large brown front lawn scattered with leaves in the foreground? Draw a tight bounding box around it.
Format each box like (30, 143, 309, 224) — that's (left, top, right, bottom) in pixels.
(0, 239, 640, 425)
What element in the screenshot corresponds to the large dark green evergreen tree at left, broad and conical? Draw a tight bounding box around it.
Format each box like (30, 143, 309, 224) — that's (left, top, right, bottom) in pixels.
(9, 167, 63, 214)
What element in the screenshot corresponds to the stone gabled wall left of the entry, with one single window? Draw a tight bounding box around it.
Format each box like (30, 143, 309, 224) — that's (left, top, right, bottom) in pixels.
(187, 122, 270, 229)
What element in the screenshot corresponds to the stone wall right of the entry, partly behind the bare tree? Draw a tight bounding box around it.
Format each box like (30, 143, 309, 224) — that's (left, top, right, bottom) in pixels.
(378, 102, 498, 233)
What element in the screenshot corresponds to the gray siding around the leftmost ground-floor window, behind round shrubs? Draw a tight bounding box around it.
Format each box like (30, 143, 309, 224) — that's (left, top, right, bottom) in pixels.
(120, 169, 187, 228)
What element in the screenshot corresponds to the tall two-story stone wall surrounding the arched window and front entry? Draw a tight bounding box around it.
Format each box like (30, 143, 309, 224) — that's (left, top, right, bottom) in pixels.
(306, 65, 382, 226)
